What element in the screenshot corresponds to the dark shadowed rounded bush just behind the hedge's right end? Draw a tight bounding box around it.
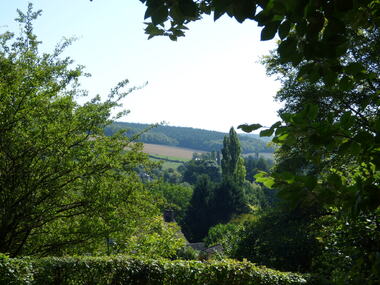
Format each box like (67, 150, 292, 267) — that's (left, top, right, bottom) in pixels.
(230, 208, 320, 272)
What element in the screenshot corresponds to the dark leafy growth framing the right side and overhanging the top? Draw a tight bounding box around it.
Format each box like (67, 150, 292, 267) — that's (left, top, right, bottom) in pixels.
(141, 0, 380, 284)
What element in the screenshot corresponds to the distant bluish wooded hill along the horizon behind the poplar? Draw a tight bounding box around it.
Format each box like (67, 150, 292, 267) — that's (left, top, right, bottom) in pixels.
(104, 122, 274, 154)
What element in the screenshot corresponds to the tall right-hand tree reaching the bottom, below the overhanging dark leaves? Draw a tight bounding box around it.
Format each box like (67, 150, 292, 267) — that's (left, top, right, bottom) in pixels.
(256, 26, 380, 284)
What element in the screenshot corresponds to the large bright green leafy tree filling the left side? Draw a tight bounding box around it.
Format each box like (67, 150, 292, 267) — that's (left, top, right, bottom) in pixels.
(0, 4, 156, 256)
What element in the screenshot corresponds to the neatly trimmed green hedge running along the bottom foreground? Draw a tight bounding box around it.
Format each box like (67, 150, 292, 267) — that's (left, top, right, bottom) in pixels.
(0, 256, 307, 285)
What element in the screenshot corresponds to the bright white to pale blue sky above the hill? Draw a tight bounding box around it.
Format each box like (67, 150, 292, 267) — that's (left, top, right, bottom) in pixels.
(0, 0, 281, 132)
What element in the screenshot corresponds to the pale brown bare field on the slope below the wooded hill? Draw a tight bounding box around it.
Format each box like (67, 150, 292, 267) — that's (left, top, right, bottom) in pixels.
(144, 143, 204, 161)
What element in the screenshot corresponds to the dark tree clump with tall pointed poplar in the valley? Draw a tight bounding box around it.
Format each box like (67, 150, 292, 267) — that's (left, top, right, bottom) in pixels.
(182, 128, 273, 242)
